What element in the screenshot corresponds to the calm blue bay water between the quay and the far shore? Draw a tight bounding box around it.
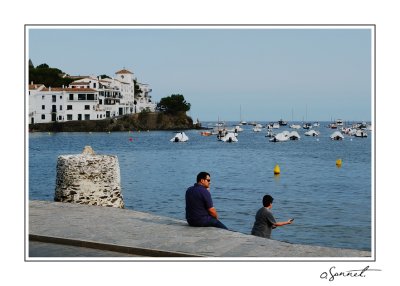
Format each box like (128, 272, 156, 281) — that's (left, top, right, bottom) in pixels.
(28, 124, 373, 250)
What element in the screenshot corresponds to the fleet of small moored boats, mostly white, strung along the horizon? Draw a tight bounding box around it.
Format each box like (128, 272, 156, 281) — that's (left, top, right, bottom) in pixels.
(170, 120, 371, 143)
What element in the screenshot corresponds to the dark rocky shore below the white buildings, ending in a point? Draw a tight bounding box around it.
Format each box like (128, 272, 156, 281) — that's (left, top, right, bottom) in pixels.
(29, 112, 198, 132)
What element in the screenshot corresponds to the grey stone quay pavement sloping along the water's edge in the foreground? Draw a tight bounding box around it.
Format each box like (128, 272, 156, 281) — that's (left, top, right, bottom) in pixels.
(28, 201, 371, 260)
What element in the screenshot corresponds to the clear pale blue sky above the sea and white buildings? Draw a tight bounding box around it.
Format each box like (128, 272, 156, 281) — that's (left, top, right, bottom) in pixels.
(27, 26, 374, 121)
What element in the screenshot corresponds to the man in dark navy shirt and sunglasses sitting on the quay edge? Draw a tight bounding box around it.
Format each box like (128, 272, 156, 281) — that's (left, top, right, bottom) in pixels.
(185, 172, 228, 229)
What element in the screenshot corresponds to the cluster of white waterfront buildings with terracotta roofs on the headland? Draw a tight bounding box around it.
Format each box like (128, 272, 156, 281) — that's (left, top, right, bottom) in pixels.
(29, 69, 156, 124)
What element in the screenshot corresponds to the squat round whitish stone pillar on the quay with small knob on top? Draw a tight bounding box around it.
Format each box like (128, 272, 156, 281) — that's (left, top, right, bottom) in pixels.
(54, 146, 124, 208)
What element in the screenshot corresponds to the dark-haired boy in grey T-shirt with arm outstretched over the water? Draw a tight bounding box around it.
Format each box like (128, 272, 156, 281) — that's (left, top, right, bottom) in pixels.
(251, 195, 293, 238)
